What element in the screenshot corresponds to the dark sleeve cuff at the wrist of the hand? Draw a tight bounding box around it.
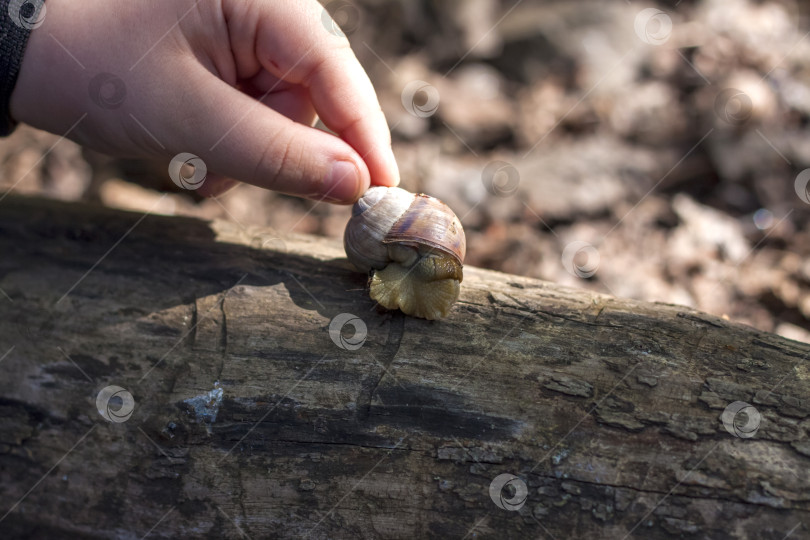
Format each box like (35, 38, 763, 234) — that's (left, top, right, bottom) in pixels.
(0, 0, 45, 137)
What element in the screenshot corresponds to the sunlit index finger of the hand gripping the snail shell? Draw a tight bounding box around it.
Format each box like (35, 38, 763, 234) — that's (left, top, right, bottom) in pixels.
(228, 0, 399, 186)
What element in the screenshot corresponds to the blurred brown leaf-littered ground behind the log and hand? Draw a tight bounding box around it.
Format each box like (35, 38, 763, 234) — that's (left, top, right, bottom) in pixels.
(0, 0, 810, 342)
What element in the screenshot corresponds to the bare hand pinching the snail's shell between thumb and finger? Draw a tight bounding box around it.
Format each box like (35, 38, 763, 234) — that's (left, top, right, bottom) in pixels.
(10, 0, 399, 203)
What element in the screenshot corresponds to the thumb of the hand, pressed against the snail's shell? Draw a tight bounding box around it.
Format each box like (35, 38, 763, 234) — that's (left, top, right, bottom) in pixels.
(178, 70, 370, 204)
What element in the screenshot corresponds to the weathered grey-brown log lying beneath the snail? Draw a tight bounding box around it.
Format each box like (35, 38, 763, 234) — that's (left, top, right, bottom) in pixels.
(0, 197, 810, 539)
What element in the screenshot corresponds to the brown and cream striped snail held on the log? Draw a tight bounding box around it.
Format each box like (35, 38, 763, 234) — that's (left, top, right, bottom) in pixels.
(343, 186, 467, 320)
